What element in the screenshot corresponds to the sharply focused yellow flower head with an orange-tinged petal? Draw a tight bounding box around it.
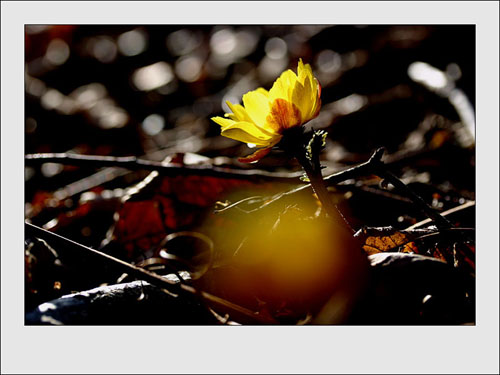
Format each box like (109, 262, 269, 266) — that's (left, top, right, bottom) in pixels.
(212, 59, 321, 163)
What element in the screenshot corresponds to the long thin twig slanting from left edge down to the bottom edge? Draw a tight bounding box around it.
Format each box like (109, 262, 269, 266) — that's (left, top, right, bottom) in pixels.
(25, 223, 277, 324)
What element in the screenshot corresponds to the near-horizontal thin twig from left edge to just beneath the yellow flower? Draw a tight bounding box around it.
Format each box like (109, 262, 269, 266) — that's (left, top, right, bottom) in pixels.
(25, 153, 302, 181)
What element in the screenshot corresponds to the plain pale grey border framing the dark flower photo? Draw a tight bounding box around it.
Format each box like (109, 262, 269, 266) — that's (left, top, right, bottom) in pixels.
(1, 1, 499, 374)
